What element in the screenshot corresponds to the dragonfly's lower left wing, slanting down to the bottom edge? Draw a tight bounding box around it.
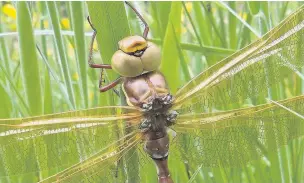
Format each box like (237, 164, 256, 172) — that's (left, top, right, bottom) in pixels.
(41, 131, 142, 183)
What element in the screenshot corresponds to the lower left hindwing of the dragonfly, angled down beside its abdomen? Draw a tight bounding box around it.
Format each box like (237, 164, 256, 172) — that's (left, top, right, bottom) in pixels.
(40, 130, 157, 183)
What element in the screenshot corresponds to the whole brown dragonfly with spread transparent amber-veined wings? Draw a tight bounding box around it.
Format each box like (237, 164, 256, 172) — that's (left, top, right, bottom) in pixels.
(0, 2, 304, 183)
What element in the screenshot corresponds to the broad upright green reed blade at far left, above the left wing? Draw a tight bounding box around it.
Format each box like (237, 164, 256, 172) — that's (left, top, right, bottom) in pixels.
(17, 2, 43, 115)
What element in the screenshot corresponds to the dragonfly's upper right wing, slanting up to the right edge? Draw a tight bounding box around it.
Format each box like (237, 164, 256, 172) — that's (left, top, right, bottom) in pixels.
(173, 6, 304, 112)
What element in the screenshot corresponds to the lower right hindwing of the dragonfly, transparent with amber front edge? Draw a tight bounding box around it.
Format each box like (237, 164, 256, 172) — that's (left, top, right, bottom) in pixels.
(170, 96, 304, 167)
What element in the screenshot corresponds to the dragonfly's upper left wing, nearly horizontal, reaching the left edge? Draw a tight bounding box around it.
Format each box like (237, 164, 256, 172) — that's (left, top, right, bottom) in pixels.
(0, 106, 146, 182)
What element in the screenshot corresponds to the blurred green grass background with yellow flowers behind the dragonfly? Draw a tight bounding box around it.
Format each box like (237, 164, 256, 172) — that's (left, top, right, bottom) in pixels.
(0, 2, 304, 182)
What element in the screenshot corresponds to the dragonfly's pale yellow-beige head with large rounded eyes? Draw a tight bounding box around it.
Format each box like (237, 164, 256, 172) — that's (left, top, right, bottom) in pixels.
(111, 36, 161, 77)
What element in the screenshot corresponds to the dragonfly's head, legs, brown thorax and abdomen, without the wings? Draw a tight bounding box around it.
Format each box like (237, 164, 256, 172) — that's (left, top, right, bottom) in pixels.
(88, 2, 177, 183)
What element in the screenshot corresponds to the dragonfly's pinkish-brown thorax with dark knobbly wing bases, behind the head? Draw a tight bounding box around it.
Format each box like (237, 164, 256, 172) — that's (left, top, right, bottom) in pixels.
(122, 71, 176, 131)
